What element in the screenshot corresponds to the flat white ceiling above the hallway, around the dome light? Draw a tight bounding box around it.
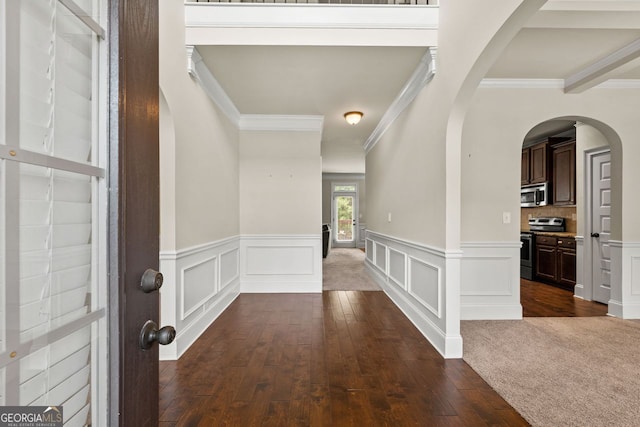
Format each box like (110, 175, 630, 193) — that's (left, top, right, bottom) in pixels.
(198, 46, 426, 173)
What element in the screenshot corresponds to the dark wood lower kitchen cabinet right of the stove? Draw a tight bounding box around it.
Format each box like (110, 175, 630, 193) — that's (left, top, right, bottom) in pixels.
(536, 236, 576, 290)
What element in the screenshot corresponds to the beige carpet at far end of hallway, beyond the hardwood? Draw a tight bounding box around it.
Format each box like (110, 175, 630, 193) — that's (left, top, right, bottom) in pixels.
(322, 248, 380, 291)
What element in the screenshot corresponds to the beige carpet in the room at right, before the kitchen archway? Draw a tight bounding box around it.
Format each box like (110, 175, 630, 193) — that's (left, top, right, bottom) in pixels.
(461, 317, 640, 427)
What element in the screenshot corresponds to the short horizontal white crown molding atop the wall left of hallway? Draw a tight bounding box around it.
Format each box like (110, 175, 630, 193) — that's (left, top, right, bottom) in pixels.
(238, 114, 324, 133)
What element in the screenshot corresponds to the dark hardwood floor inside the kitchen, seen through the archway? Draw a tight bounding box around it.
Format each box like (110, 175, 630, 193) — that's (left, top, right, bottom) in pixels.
(520, 279, 608, 317)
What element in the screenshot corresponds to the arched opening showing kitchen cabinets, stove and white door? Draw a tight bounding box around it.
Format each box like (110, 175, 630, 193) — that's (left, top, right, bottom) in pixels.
(521, 117, 621, 316)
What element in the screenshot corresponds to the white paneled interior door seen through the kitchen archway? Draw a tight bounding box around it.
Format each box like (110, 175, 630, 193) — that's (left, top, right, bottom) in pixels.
(590, 151, 611, 304)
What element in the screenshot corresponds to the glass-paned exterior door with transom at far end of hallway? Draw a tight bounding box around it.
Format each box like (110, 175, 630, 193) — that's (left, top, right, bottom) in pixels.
(331, 183, 359, 248)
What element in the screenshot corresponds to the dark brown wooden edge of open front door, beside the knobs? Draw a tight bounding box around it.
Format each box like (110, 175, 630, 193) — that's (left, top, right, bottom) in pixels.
(109, 0, 159, 426)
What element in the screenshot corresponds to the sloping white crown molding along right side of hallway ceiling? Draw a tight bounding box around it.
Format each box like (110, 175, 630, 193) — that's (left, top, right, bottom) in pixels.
(364, 47, 437, 154)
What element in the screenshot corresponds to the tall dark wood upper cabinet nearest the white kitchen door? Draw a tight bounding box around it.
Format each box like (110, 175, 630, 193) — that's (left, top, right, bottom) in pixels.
(552, 139, 576, 205)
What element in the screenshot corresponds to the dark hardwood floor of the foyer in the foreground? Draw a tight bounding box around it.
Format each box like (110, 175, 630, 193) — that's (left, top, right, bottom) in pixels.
(160, 291, 528, 427)
